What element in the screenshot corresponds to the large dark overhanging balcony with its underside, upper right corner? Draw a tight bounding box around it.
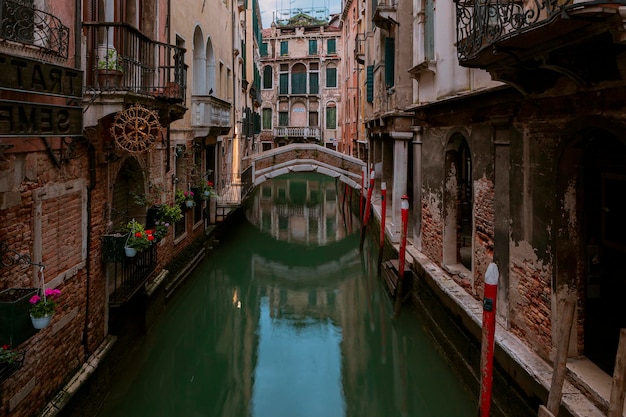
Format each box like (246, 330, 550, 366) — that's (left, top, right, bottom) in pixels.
(456, 0, 626, 93)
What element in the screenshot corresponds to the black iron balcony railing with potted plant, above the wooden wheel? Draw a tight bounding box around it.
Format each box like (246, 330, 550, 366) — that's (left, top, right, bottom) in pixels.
(83, 22, 187, 102)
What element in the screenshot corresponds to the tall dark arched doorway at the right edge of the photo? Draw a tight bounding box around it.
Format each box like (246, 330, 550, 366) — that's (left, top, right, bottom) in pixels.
(583, 131, 626, 374)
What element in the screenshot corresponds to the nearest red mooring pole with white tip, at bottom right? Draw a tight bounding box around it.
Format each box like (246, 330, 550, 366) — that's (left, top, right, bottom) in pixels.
(479, 263, 499, 417)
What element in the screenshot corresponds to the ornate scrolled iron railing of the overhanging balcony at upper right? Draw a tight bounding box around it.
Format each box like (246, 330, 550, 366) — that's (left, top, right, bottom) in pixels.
(456, 0, 591, 62)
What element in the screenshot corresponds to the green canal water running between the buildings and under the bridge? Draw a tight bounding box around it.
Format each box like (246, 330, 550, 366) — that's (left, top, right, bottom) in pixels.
(70, 175, 477, 417)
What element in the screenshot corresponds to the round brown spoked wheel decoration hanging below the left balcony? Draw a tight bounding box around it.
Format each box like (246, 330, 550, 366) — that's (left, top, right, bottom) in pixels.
(111, 104, 161, 154)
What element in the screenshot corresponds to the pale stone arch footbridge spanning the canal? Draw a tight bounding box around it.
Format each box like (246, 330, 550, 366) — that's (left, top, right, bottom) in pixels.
(241, 143, 366, 196)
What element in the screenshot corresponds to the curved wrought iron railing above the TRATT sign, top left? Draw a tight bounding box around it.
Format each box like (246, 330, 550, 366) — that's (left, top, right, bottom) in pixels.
(0, 0, 70, 58)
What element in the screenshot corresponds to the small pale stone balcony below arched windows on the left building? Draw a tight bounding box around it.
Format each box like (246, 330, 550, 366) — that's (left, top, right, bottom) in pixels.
(191, 95, 232, 136)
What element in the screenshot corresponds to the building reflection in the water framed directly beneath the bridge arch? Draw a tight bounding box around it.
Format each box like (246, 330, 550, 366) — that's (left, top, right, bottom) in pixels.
(246, 174, 358, 245)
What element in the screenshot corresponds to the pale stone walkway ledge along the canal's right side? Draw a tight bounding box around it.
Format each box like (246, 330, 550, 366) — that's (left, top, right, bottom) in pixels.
(372, 195, 612, 417)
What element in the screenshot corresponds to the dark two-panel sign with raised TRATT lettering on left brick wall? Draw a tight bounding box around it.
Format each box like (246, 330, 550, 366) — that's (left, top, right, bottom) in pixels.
(0, 53, 83, 137)
